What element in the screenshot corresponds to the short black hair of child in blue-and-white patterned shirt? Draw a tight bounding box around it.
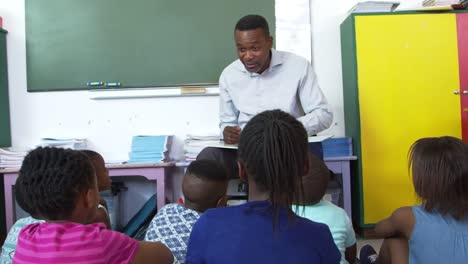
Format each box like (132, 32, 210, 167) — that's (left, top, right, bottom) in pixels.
(185, 159, 228, 182)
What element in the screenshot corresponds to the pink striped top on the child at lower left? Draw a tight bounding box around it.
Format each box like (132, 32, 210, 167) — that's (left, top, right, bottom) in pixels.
(13, 222, 138, 264)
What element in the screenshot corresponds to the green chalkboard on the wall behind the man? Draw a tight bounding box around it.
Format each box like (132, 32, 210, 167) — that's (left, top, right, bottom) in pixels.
(25, 0, 275, 91)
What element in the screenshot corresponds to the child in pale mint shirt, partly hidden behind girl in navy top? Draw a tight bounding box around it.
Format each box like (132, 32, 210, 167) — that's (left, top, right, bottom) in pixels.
(295, 154, 356, 264)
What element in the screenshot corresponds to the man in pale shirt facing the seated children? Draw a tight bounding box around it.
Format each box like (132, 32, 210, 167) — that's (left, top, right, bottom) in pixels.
(197, 15, 333, 177)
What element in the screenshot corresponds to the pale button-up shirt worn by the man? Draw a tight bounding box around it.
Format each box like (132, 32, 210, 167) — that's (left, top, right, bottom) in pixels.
(219, 49, 333, 135)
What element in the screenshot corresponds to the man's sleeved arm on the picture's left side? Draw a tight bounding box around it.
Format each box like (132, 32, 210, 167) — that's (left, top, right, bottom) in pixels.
(219, 73, 239, 139)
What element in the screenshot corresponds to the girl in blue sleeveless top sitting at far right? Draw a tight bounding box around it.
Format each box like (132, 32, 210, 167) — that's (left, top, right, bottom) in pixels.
(360, 136, 468, 264)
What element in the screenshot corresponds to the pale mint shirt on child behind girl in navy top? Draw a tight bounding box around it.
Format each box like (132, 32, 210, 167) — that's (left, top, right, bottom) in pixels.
(293, 200, 356, 264)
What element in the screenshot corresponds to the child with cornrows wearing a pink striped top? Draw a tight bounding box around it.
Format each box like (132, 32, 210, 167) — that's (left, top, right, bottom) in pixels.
(13, 147, 173, 264)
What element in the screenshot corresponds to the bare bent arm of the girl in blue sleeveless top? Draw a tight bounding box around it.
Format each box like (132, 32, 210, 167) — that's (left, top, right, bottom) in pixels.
(374, 207, 414, 239)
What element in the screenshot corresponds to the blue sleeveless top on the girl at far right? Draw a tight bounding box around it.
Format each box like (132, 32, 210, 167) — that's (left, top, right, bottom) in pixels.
(409, 206, 468, 264)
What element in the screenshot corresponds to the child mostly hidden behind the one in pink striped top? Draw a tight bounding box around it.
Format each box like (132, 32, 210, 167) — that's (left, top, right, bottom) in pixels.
(0, 150, 111, 264)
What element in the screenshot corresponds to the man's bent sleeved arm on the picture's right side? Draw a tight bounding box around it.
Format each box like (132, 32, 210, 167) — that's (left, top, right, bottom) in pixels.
(298, 63, 333, 135)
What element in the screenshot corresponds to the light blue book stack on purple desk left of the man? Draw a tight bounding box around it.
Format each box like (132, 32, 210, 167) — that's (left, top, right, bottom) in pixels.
(128, 136, 172, 163)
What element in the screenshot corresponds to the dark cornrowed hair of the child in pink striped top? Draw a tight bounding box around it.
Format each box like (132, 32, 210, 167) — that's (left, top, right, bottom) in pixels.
(15, 147, 96, 220)
